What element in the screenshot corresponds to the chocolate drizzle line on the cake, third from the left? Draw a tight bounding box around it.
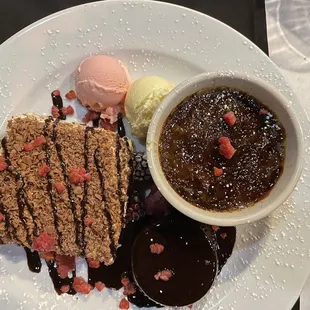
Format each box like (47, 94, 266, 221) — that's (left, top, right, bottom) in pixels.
(52, 120, 80, 249)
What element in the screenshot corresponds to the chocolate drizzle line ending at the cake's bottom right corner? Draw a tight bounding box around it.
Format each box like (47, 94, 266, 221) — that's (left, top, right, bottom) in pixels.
(94, 149, 116, 258)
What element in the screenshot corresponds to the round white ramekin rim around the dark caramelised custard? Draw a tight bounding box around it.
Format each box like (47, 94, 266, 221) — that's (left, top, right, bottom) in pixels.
(147, 73, 303, 226)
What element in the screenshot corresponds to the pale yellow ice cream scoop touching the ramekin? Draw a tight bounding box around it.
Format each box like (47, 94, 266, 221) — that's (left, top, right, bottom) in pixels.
(125, 76, 174, 138)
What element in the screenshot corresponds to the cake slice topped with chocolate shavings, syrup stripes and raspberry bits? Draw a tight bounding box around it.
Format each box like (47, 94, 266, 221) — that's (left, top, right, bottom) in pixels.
(0, 115, 132, 265)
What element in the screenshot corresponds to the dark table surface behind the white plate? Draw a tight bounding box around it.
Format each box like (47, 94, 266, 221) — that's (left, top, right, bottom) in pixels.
(0, 0, 300, 310)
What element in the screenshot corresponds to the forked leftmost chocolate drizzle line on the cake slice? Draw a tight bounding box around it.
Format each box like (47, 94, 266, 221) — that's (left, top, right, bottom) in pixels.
(1, 138, 38, 245)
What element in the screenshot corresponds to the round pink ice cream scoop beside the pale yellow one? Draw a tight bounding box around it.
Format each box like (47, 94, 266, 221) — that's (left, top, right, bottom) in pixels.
(75, 55, 132, 112)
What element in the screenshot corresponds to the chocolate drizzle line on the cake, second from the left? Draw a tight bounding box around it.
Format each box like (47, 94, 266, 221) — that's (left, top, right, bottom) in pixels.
(43, 118, 62, 249)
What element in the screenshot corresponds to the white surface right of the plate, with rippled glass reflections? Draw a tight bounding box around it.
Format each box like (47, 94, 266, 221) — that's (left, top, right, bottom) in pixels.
(266, 0, 310, 310)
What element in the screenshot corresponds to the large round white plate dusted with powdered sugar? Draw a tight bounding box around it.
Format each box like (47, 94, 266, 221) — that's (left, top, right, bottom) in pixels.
(0, 1, 310, 310)
